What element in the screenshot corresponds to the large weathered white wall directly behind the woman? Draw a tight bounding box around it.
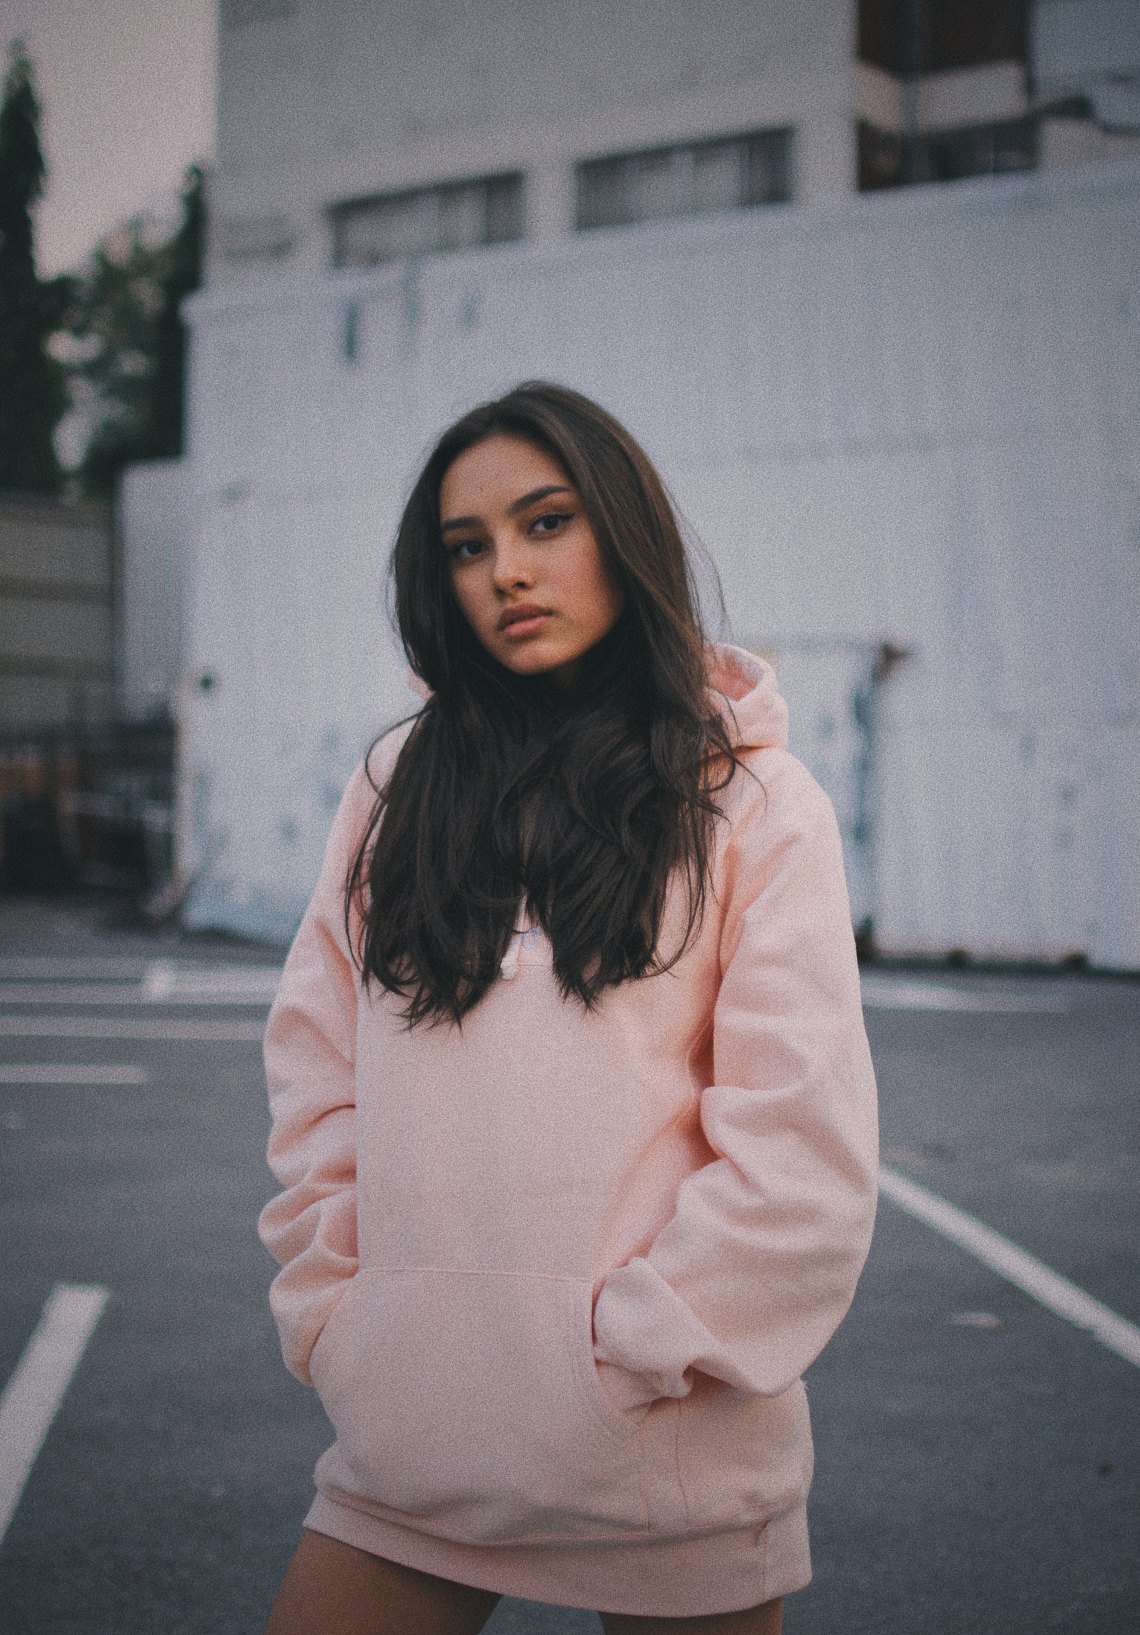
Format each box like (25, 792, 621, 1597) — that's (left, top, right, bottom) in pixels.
(182, 165, 1140, 968)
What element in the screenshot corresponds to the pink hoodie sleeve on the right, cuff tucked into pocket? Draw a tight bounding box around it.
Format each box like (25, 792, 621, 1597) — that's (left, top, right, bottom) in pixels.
(594, 750, 878, 1406)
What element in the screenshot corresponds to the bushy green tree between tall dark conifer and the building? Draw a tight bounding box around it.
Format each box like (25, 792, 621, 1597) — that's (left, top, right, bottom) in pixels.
(67, 165, 203, 499)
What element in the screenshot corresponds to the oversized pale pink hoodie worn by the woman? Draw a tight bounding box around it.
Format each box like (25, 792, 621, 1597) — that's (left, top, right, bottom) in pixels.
(260, 647, 877, 1617)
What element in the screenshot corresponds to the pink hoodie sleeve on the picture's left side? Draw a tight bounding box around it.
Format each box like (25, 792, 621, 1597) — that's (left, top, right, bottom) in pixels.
(258, 752, 375, 1385)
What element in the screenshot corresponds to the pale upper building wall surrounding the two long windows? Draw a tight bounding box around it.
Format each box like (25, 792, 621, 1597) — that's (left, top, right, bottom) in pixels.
(209, 0, 855, 284)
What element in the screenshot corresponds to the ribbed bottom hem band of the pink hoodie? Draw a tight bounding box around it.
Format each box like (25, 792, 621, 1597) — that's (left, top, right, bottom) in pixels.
(304, 1493, 811, 1617)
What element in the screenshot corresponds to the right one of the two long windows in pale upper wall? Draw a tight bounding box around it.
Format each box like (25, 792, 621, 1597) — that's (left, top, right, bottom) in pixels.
(576, 129, 792, 231)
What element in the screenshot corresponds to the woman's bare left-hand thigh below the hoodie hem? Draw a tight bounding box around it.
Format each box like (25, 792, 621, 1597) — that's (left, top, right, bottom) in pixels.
(265, 1529, 499, 1635)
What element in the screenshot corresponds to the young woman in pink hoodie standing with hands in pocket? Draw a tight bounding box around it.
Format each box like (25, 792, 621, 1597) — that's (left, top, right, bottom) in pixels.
(260, 383, 877, 1635)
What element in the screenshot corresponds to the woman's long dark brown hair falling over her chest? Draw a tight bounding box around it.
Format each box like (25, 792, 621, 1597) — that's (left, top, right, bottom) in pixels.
(345, 381, 736, 1025)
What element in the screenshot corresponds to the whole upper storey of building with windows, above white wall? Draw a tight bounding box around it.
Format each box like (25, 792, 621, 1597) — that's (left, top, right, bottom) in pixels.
(209, 0, 1140, 284)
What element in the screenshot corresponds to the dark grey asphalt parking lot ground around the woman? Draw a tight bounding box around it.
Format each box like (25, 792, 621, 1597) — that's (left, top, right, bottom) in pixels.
(0, 901, 1140, 1635)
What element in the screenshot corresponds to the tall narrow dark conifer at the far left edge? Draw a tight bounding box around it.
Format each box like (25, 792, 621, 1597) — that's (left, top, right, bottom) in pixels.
(0, 41, 70, 494)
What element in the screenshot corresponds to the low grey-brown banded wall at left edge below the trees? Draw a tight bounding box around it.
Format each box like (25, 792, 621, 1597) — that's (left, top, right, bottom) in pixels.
(0, 495, 114, 737)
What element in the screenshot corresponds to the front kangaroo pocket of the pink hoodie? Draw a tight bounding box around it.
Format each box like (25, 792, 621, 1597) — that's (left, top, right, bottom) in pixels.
(311, 1267, 648, 1542)
